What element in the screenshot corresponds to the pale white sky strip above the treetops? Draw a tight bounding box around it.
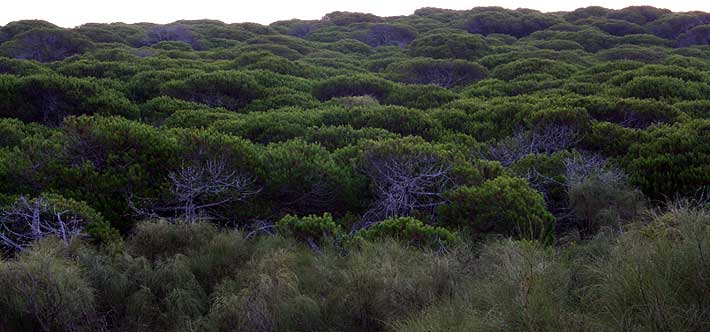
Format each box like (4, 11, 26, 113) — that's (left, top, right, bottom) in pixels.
(0, 0, 710, 27)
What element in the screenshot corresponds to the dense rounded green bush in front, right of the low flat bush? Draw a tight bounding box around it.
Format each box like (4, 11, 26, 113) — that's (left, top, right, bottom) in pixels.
(439, 176, 555, 243)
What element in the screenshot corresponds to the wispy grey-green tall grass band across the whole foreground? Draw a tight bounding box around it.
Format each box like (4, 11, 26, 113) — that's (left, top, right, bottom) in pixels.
(0, 206, 710, 332)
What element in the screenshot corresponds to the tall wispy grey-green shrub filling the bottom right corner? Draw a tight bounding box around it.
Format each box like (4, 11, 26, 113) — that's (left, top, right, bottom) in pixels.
(584, 207, 710, 331)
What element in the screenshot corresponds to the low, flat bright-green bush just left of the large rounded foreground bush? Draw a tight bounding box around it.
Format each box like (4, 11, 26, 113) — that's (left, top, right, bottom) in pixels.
(356, 217, 457, 248)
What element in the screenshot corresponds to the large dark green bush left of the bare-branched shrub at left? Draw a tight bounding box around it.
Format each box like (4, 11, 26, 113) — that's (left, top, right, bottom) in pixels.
(57, 117, 178, 231)
